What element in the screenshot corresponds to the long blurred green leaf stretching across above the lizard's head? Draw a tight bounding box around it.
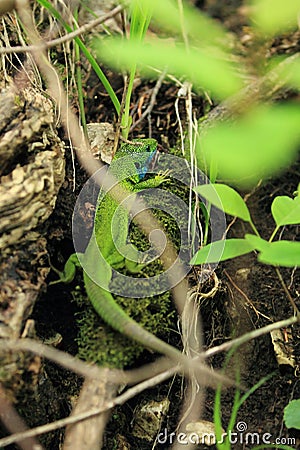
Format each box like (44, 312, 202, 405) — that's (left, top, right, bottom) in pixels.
(95, 37, 241, 99)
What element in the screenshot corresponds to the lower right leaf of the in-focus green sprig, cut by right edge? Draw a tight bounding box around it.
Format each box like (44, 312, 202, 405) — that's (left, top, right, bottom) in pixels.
(258, 241, 300, 267)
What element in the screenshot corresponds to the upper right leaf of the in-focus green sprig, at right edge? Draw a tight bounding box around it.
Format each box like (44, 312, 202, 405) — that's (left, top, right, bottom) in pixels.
(271, 195, 300, 226)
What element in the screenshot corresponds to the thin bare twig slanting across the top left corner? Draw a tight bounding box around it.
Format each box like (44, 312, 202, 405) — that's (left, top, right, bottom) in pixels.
(0, 6, 124, 55)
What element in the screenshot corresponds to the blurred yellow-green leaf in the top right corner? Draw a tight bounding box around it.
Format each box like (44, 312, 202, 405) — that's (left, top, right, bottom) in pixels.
(252, 0, 300, 34)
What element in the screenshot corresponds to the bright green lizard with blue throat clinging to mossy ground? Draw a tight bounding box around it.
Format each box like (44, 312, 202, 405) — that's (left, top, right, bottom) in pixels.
(54, 139, 230, 384)
